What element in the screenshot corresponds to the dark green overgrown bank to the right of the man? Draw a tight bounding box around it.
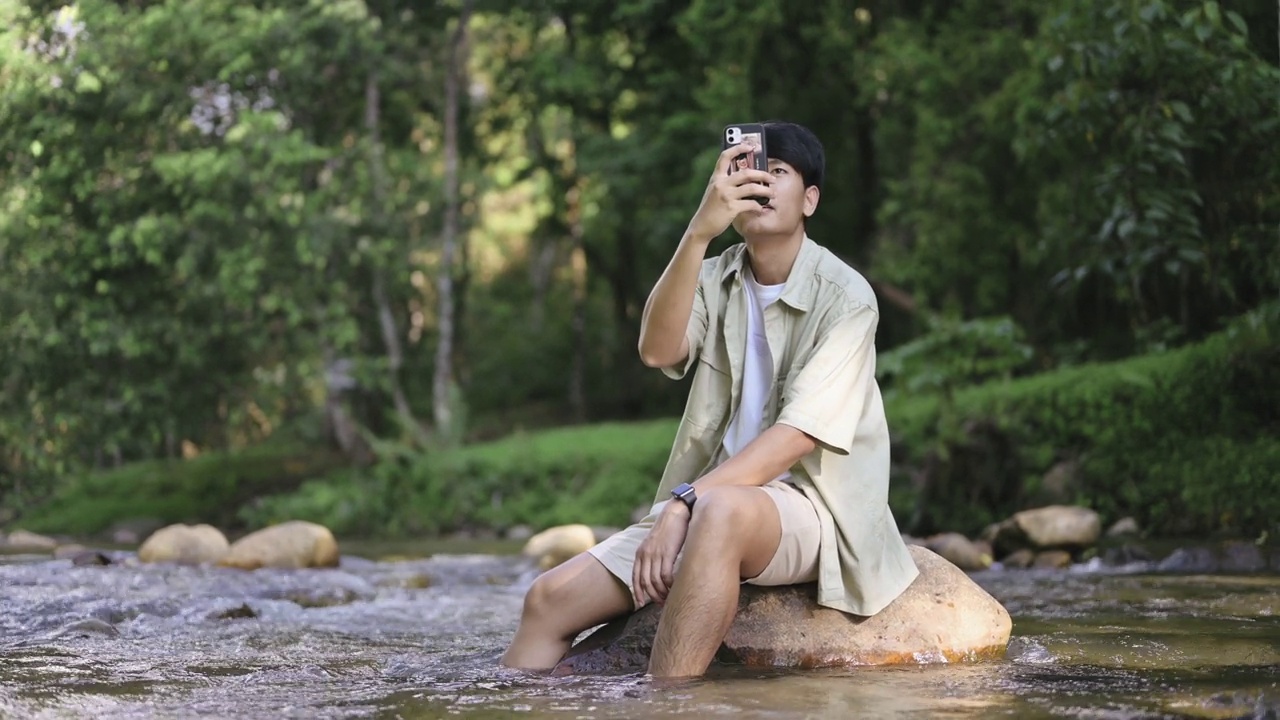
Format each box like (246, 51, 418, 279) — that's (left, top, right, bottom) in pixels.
(891, 304, 1280, 534)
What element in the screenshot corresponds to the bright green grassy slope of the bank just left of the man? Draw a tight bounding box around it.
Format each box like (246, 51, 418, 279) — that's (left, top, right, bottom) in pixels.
(239, 420, 676, 537)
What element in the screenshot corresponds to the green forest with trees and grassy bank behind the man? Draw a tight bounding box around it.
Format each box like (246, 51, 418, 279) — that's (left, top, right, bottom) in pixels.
(0, 0, 1280, 538)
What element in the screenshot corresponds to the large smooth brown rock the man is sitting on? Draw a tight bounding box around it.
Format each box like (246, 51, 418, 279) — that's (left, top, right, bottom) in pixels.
(552, 546, 1012, 675)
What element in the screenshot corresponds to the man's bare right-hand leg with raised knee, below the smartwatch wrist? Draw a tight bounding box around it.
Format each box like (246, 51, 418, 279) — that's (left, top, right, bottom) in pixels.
(649, 487, 782, 678)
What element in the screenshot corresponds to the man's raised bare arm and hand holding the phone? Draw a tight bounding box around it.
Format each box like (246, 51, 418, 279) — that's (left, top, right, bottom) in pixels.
(639, 143, 773, 368)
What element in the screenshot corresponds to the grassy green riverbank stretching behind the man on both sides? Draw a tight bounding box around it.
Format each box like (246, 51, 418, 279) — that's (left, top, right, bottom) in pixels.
(10, 308, 1280, 538)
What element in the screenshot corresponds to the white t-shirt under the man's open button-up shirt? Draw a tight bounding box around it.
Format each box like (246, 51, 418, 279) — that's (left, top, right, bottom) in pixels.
(724, 273, 791, 480)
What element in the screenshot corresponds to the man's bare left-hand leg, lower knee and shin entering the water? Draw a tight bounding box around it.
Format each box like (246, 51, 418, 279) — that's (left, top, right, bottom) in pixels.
(502, 552, 632, 670)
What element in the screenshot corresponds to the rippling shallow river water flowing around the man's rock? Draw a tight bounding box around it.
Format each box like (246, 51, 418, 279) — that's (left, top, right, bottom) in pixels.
(0, 544, 1280, 720)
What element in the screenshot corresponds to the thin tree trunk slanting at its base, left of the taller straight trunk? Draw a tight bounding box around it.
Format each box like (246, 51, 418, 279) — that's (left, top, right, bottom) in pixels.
(365, 73, 425, 443)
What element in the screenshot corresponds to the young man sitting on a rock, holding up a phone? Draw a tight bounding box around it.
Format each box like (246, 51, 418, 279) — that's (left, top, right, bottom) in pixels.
(503, 123, 918, 678)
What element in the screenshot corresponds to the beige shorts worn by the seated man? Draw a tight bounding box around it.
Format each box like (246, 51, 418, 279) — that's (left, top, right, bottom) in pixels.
(588, 480, 822, 602)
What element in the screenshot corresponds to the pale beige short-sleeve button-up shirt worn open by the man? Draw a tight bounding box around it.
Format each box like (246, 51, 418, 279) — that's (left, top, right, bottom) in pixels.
(654, 237, 919, 615)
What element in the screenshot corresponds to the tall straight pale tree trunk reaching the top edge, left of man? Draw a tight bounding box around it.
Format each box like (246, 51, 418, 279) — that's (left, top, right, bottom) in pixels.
(431, 0, 471, 438)
